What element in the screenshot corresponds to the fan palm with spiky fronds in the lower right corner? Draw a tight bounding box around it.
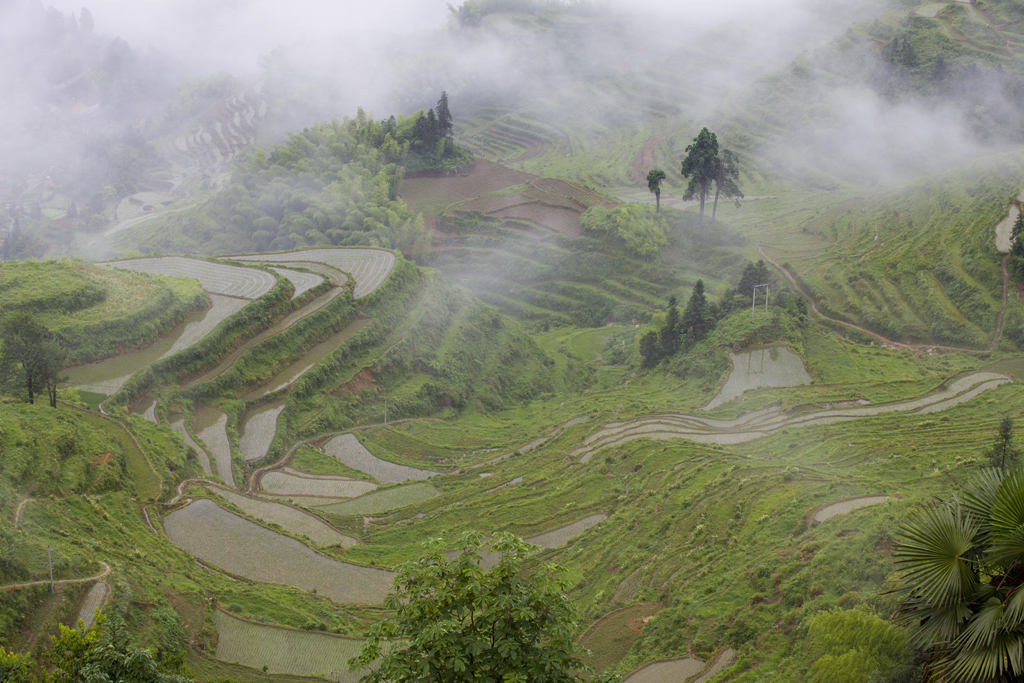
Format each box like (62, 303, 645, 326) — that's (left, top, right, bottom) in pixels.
(893, 468, 1024, 683)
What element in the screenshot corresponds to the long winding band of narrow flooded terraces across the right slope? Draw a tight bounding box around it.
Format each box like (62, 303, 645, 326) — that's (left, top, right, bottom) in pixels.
(572, 373, 1012, 462)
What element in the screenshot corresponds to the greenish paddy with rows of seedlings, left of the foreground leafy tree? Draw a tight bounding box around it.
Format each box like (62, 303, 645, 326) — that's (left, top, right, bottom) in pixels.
(213, 609, 366, 683)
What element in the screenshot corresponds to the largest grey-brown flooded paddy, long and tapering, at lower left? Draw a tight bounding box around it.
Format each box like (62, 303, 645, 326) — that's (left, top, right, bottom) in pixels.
(164, 499, 393, 604)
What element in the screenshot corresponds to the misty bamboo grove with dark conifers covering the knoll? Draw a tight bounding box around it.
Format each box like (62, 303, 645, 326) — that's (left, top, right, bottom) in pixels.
(211, 95, 473, 259)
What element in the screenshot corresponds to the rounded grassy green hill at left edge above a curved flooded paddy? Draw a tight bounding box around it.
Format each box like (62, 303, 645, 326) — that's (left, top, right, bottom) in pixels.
(0, 259, 209, 364)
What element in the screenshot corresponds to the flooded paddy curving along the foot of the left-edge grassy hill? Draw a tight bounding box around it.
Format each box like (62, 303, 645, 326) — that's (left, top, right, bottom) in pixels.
(65, 296, 249, 396)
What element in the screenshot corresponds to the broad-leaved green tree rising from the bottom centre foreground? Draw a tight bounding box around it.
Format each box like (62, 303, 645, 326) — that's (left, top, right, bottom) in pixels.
(349, 533, 617, 683)
